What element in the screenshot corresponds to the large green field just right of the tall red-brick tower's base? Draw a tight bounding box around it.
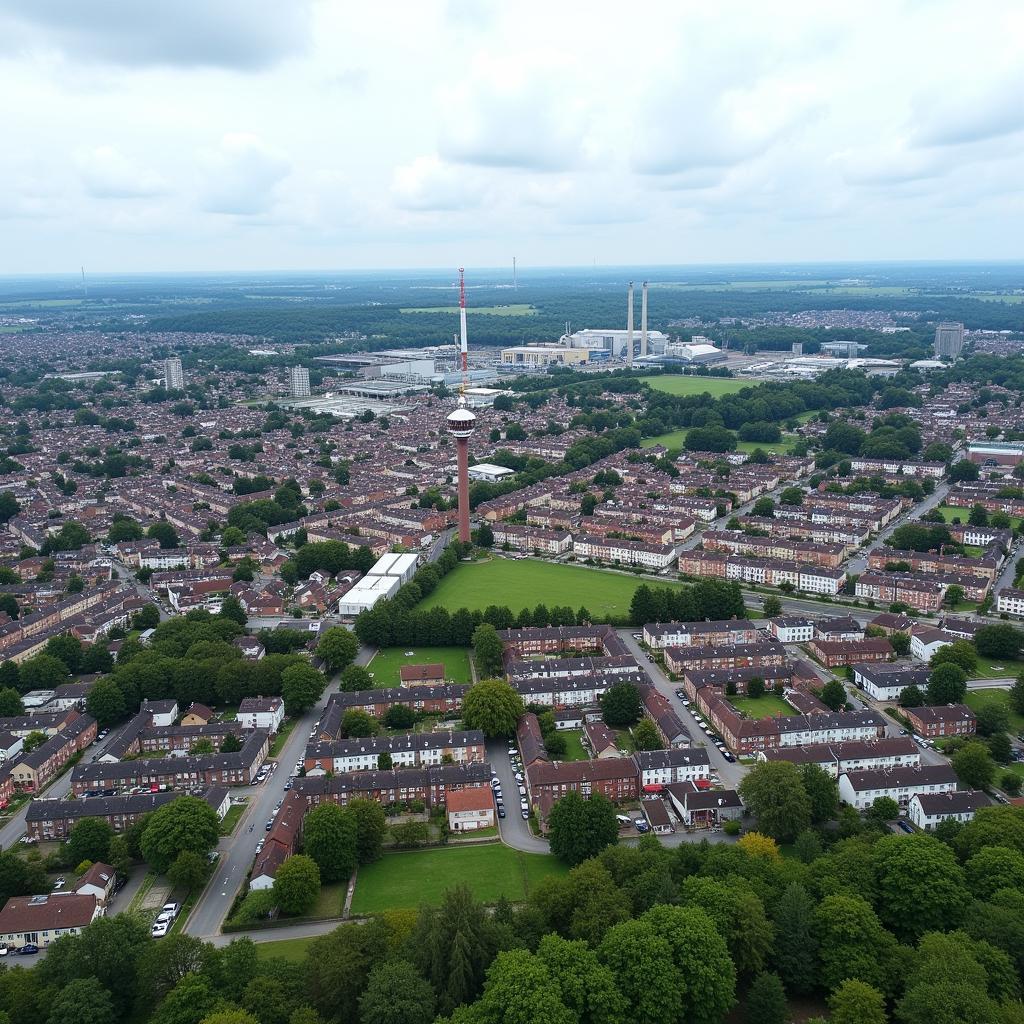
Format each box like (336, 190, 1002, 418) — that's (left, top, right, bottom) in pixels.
(415, 558, 679, 614)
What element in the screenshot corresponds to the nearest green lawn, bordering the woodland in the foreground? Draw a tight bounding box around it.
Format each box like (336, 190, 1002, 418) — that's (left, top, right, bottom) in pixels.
(352, 843, 568, 914)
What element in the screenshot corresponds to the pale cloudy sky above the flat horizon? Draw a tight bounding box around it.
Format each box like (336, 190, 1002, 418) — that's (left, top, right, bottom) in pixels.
(0, 0, 1024, 273)
